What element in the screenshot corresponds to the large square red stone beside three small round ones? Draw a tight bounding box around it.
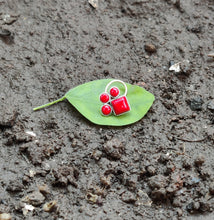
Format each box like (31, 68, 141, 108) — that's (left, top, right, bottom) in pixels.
(111, 96, 130, 115)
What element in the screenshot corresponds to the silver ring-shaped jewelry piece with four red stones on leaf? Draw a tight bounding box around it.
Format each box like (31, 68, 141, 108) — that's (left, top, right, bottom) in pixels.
(100, 80, 131, 116)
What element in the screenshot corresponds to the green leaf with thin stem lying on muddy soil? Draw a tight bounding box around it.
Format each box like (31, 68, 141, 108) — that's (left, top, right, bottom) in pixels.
(34, 79, 155, 126)
